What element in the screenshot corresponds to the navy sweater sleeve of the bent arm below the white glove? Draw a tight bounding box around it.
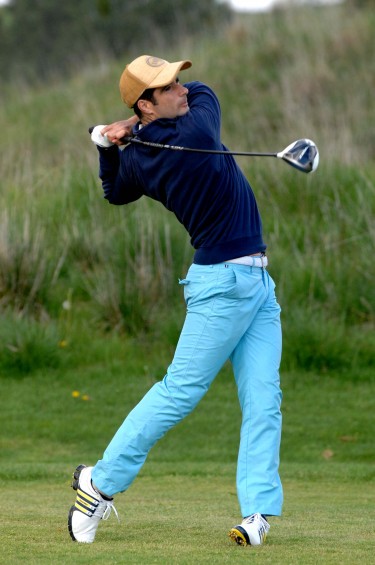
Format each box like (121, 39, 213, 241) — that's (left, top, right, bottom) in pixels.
(98, 145, 143, 205)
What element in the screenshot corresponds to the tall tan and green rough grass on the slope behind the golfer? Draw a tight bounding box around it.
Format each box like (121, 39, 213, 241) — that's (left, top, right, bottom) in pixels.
(0, 5, 375, 369)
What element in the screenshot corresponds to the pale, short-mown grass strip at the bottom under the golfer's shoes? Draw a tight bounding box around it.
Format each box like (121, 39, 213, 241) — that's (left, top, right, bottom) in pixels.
(0, 473, 375, 565)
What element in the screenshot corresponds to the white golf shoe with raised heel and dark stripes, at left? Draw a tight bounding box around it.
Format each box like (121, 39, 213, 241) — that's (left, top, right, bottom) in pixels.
(68, 465, 118, 543)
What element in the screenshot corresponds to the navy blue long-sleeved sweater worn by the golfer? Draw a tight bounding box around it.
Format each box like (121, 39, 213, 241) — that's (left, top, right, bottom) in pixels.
(98, 82, 266, 265)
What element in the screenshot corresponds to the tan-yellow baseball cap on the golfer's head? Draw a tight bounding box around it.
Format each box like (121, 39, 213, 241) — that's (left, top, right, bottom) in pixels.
(120, 55, 192, 108)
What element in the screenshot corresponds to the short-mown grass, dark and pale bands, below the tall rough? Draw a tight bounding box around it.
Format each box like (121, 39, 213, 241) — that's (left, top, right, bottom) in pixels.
(0, 340, 375, 564)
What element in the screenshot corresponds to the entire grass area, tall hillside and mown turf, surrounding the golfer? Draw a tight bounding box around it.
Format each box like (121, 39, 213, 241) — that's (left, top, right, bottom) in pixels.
(0, 5, 375, 565)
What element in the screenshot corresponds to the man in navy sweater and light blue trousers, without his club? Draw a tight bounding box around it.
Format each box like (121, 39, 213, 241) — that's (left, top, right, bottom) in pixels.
(68, 55, 283, 545)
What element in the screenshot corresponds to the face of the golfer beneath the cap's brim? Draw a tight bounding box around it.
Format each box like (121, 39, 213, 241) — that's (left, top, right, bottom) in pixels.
(142, 78, 189, 121)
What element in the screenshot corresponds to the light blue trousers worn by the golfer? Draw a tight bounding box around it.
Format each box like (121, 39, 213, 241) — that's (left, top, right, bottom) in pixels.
(92, 263, 283, 517)
